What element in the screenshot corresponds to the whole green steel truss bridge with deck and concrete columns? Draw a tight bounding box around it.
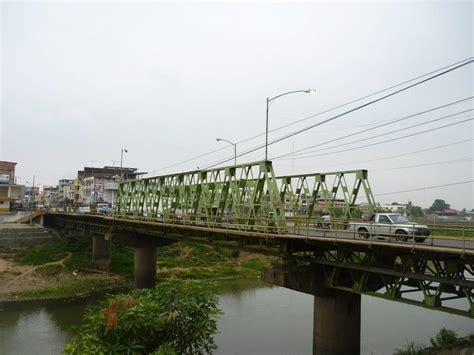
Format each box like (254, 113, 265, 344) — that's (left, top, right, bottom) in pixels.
(41, 161, 474, 354)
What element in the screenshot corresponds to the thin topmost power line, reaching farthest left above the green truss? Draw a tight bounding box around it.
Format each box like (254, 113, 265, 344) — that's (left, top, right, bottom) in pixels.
(153, 57, 473, 172)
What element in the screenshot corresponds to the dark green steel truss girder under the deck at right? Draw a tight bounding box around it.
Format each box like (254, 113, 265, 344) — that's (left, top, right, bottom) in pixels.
(314, 250, 474, 318)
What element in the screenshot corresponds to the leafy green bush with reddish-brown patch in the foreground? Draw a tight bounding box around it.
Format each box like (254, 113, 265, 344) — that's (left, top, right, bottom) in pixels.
(65, 280, 221, 355)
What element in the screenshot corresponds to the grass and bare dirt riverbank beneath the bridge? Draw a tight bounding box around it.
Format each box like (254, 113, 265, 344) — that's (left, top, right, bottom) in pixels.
(0, 237, 276, 303)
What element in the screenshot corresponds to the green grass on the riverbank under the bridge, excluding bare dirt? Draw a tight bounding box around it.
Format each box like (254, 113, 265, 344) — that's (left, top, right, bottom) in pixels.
(14, 236, 275, 299)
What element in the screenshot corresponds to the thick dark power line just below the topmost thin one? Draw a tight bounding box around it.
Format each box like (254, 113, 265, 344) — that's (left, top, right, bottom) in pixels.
(206, 59, 473, 168)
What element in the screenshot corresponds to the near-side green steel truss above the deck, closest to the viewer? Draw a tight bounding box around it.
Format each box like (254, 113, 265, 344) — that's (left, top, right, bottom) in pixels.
(116, 161, 285, 230)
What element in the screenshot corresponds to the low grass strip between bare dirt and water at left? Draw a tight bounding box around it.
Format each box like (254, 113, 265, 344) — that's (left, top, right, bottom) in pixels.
(14, 279, 123, 299)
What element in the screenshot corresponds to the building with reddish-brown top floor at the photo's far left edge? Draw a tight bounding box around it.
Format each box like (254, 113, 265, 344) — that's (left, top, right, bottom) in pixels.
(0, 161, 25, 213)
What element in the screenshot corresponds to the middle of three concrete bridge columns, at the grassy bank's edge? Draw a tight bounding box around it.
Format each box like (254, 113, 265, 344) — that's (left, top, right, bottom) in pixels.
(133, 245, 156, 288)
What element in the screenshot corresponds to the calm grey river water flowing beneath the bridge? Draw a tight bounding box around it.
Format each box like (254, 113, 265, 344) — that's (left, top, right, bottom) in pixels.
(0, 280, 474, 355)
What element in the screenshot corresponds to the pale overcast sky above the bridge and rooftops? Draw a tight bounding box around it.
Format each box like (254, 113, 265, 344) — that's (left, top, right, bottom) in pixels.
(0, 1, 474, 209)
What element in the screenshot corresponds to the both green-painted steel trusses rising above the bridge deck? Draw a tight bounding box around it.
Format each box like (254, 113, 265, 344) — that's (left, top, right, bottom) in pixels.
(115, 161, 375, 233)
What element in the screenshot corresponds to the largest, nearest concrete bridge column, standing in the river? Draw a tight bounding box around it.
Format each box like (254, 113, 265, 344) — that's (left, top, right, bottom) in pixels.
(313, 290, 360, 355)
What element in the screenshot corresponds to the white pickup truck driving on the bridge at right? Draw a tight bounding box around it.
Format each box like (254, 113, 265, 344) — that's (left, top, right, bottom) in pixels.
(349, 213, 431, 243)
